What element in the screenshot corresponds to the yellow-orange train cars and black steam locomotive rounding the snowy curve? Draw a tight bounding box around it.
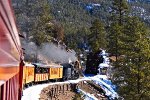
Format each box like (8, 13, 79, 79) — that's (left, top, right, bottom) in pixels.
(23, 63, 79, 88)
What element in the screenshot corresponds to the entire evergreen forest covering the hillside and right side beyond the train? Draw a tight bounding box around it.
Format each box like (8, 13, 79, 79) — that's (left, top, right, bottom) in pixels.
(12, 0, 150, 100)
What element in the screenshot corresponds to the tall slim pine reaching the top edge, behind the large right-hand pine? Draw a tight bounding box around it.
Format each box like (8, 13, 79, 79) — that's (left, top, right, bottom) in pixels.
(108, 0, 128, 62)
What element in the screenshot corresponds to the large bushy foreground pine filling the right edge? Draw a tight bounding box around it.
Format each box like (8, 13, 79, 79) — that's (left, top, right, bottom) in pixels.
(114, 17, 150, 100)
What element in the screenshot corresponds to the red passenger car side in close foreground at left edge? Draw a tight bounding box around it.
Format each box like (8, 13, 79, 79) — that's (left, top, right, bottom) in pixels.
(0, 0, 23, 100)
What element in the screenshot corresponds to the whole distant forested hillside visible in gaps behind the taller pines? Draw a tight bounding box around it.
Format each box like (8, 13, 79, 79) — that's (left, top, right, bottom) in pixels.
(12, 0, 150, 49)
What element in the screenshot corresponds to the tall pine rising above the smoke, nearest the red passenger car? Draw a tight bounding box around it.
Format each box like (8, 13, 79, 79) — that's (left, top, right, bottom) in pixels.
(32, 0, 53, 46)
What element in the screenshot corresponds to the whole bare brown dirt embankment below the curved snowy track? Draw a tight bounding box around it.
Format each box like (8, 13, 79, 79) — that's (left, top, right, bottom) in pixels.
(39, 81, 107, 100)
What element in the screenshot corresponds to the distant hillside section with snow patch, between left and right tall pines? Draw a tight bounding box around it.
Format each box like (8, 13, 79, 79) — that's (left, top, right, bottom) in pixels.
(50, 0, 109, 33)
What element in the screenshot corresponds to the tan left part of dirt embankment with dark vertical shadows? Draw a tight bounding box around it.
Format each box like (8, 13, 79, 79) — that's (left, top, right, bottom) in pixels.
(40, 84, 77, 100)
